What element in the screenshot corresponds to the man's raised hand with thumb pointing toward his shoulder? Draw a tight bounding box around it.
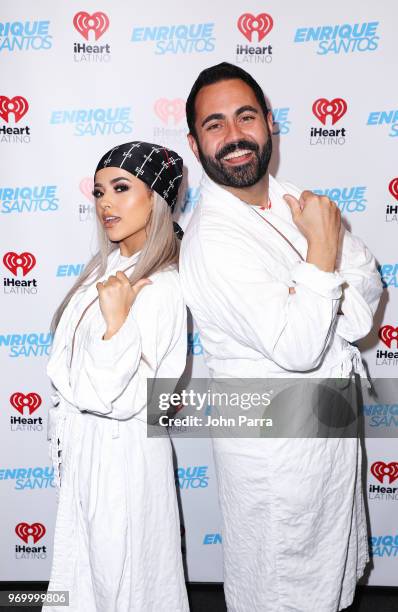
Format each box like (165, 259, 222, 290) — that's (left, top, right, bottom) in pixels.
(284, 191, 341, 272)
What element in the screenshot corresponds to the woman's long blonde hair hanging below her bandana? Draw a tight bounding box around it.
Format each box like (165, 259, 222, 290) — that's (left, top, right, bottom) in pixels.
(51, 191, 179, 333)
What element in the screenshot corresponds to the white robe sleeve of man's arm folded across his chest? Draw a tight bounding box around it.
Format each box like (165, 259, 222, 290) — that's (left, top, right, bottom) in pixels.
(197, 231, 343, 371)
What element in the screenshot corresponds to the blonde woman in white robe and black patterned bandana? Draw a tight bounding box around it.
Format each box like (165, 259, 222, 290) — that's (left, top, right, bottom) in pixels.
(47, 142, 188, 612)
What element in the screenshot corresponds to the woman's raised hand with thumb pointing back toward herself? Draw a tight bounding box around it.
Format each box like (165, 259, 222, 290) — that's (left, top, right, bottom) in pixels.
(96, 272, 152, 340)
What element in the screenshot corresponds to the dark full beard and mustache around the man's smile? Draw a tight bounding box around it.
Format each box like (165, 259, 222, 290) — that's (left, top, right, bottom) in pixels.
(197, 132, 272, 188)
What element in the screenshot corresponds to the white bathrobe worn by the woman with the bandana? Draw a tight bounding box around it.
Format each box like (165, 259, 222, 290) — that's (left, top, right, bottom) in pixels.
(47, 249, 188, 612)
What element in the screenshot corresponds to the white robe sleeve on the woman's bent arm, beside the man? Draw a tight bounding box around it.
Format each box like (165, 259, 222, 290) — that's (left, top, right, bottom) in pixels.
(74, 275, 186, 419)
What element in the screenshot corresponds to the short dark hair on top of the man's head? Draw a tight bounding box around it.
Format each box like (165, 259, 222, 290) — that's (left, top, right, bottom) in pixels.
(186, 62, 269, 138)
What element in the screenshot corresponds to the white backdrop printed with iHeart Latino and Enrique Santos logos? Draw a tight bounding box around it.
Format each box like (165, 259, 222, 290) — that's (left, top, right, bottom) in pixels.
(0, 0, 398, 586)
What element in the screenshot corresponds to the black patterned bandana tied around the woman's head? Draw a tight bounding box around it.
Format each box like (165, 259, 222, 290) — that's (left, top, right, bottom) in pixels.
(95, 141, 183, 210)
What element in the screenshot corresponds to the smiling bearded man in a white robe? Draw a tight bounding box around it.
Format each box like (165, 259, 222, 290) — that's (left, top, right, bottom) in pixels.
(180, 63, 382, 612)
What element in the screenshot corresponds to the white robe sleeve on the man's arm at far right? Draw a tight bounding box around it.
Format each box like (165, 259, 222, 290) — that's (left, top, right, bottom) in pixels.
(336, 226, 383, 342)
